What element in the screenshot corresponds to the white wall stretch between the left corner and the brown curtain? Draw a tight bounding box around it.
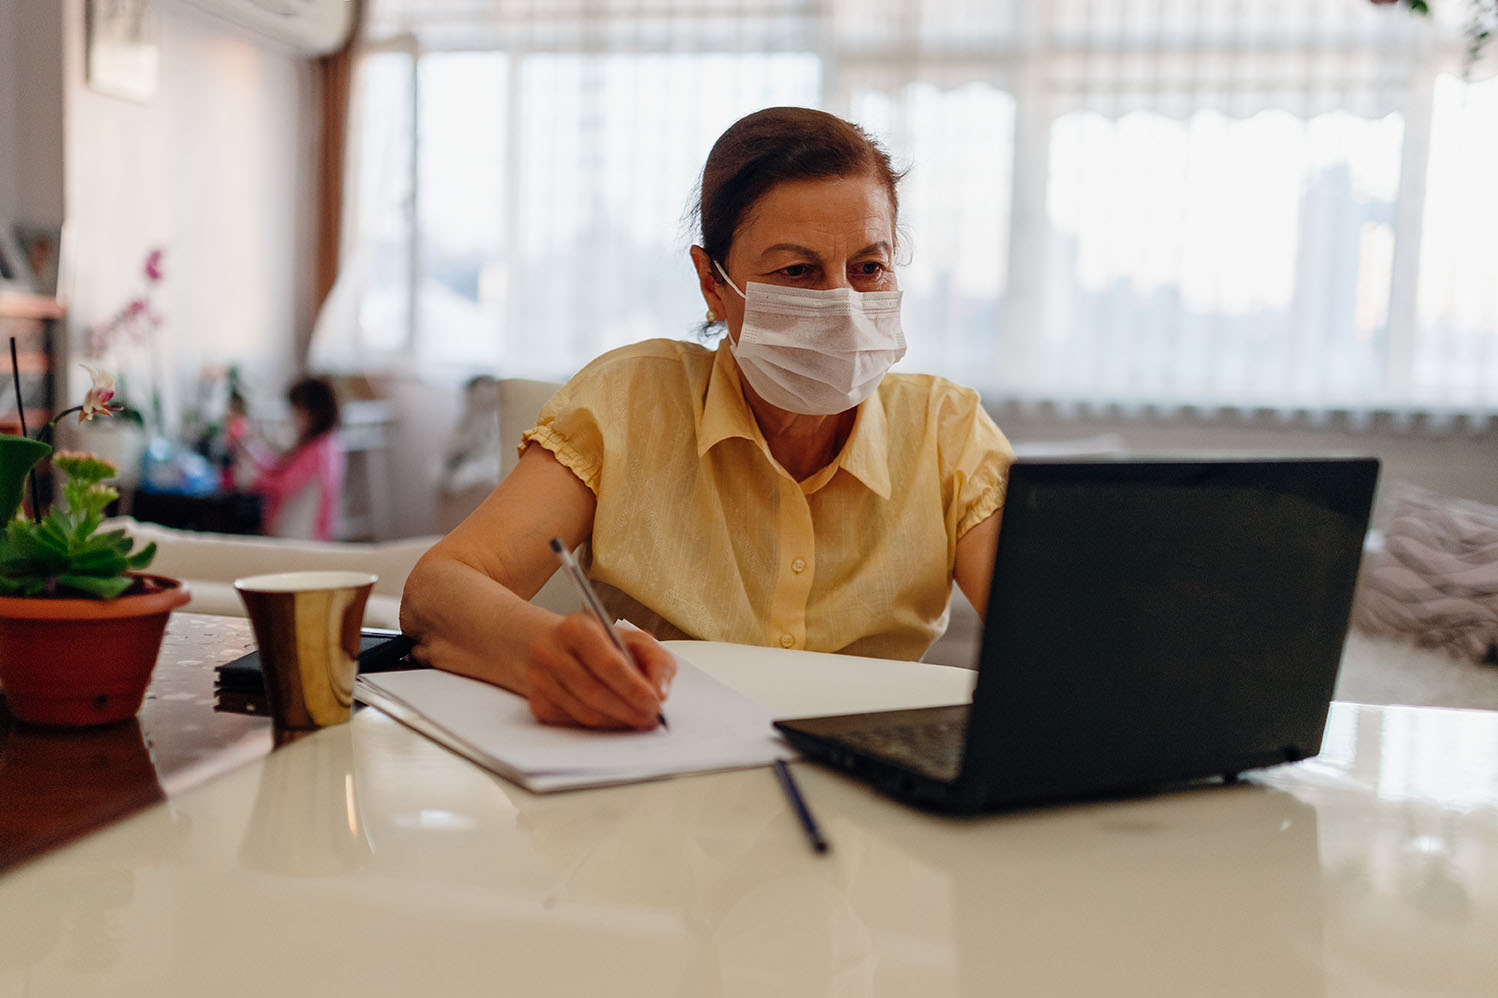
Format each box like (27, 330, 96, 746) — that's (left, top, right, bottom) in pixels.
(59, 0, 318, 430)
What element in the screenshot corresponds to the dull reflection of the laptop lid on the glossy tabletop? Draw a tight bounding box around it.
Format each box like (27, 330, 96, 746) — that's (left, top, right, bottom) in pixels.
(947, 784, 1327, 998)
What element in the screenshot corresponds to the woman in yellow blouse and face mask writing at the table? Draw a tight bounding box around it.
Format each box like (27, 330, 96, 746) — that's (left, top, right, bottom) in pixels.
(401, 108, 1013, 728)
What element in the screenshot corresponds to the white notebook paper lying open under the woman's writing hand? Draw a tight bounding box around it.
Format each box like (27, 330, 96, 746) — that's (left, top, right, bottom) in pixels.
(354, 658, 795, 793)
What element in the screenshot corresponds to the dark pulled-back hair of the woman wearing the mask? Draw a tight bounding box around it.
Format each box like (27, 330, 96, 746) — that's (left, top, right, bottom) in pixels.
(695, 108, 903, 267)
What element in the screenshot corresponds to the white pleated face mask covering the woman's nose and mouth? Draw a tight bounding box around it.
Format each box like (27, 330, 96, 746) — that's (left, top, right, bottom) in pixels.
(713, 261, 905, 415)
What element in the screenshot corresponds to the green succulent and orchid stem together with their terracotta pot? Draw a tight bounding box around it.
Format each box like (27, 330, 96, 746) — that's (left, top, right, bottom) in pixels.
(0, 355, 187, 727)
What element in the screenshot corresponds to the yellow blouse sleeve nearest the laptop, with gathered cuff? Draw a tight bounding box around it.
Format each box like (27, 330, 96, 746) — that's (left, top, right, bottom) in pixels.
(938, 385, 1014, 539)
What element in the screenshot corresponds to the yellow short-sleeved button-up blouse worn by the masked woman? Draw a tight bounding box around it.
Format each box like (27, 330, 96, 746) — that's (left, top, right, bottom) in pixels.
(520, 340, 1014, 659)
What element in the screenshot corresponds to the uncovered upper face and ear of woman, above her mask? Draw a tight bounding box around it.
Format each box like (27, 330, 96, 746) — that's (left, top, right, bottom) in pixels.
(692, 174, 899, 343)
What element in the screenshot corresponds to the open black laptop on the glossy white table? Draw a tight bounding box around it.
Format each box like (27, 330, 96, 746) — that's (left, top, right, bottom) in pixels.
(776, 459, 1378, 811)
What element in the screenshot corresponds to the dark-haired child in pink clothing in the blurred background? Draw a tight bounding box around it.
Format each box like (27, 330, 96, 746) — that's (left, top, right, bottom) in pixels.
(252, 378, 345, 541)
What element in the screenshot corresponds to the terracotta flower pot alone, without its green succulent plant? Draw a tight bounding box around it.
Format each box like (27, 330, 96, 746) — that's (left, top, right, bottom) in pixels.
(0, 575, 187, 727)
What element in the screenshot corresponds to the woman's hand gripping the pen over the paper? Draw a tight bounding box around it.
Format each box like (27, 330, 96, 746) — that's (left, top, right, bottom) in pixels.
(526, 613, 676, 730)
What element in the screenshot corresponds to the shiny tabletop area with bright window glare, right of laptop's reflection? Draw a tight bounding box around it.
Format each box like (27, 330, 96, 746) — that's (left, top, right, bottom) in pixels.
(1258, 704, 1498, 995)
